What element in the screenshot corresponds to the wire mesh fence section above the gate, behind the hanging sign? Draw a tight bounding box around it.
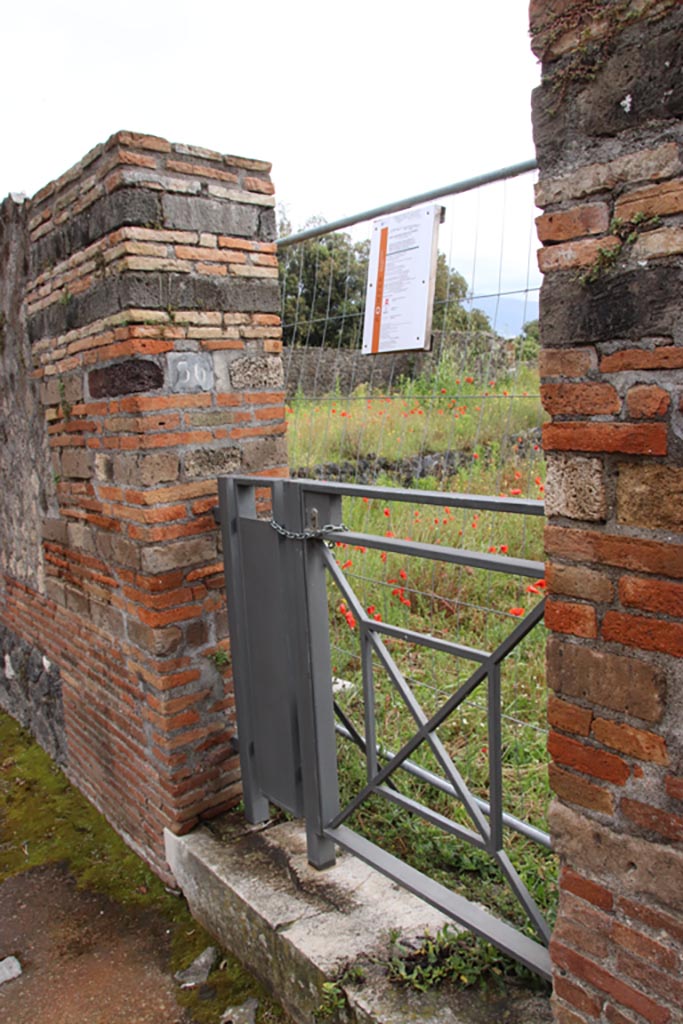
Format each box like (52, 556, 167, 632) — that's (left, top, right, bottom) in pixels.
(279, 162, 544, 497)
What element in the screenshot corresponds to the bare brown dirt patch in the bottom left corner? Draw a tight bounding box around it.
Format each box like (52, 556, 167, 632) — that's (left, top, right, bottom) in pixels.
(0, 865, 190, 1024)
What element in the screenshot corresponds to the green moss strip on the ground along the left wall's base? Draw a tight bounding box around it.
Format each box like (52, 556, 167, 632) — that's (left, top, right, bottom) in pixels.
(0, 713, 288, 1024)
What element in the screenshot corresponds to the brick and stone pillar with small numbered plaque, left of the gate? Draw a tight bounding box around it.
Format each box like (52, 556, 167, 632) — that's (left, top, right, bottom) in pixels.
(0, 132, 287, 872)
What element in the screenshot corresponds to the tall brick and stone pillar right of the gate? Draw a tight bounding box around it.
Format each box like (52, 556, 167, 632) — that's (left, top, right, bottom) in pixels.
(530, 6, 683, 1024)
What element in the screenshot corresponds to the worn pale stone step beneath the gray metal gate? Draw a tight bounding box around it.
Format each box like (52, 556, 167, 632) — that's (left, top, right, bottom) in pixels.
(166, 815, 552, 1024)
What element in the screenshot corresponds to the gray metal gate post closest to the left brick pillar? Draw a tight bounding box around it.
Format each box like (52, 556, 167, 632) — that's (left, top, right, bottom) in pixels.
(218, 476, 270, 824)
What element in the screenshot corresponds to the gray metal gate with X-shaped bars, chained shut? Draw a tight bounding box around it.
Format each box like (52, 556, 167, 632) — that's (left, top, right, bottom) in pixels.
(218, 476, 550, 978)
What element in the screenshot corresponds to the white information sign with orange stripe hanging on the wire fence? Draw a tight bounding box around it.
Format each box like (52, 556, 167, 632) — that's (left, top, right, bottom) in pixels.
(362, 205, 443, 355)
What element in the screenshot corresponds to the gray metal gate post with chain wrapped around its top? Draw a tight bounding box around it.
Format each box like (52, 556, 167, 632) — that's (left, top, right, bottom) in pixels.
(272, 480, 341, 868)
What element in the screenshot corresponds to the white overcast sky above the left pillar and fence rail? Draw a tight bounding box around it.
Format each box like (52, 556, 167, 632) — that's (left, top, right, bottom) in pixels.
(0, 0, 540, 227)
